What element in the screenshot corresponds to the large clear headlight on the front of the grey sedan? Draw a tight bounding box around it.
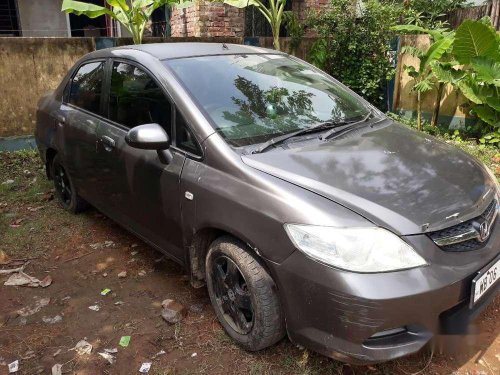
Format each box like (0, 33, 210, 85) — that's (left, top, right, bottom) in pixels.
(285, 224, 427, 273)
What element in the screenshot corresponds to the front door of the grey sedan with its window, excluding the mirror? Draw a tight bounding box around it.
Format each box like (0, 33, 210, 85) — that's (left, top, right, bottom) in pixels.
(97, 60, 186, 261)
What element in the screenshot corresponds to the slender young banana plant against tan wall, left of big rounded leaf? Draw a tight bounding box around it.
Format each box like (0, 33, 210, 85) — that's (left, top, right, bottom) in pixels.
(392, 25, 455, 130)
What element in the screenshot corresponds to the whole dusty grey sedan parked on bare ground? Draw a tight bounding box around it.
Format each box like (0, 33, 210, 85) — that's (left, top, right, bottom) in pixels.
(36, 43, 500, 363)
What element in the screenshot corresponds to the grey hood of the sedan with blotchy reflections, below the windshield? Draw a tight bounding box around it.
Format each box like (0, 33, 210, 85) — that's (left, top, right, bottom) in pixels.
(242, 120, 496, 235)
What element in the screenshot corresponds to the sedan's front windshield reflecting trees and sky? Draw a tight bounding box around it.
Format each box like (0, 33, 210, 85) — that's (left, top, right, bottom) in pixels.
(165, 54, 369, 147)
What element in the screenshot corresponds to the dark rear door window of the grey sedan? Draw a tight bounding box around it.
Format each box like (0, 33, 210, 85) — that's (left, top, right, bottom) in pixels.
(68, 61, 104, 114)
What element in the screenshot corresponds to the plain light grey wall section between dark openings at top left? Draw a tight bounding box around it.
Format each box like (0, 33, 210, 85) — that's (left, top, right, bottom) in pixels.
(17, 0, 71, 37)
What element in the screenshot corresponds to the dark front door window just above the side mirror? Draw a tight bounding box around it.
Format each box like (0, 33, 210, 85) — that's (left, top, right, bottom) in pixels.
(107, 62, 172, 137)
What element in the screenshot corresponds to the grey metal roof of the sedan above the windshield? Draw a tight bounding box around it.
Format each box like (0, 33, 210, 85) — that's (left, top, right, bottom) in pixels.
(84, 42, 283, 60)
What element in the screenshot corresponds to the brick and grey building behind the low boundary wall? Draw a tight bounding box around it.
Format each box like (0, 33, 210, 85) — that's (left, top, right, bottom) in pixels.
(0, 0, 329, 37)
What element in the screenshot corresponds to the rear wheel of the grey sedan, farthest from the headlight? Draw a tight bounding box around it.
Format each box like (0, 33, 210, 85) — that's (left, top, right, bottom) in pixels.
(50, 155, 89, 214)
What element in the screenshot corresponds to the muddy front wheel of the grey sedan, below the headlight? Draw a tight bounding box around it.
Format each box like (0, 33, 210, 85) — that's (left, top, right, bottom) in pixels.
(205, 236, 285, 351)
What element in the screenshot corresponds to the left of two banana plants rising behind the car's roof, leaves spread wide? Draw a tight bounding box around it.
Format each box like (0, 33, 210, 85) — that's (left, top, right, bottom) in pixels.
(61, 0, 187, 44)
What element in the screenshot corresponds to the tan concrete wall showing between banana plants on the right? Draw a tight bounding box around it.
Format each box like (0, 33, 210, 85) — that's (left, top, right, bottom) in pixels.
(393, 35, 467, 127)
